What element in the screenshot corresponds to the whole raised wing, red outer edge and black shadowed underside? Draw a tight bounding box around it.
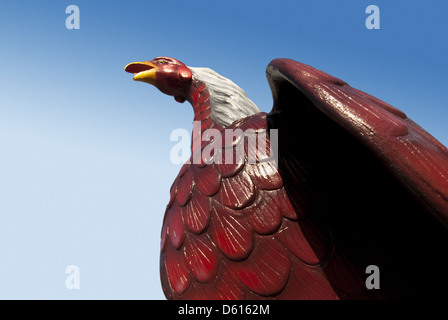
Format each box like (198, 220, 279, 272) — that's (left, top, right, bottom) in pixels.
(267, 59, 448, 298)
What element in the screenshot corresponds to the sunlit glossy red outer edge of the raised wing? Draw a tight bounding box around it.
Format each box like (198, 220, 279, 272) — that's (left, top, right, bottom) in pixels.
(267, 59, 448, 227)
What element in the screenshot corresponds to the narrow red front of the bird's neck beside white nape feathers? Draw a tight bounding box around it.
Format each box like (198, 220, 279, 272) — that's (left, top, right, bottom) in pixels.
(188, 80, 224, 152)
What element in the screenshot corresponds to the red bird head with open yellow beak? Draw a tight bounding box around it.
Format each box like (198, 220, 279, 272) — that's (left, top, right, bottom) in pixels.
(124, 57, 192, 102)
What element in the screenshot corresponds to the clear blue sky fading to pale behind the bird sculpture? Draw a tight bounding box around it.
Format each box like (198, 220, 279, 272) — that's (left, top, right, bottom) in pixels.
(0, 0, 448, 299)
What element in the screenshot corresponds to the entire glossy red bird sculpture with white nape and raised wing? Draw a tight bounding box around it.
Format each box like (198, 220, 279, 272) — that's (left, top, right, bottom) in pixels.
(125, 57, 448, 299)
